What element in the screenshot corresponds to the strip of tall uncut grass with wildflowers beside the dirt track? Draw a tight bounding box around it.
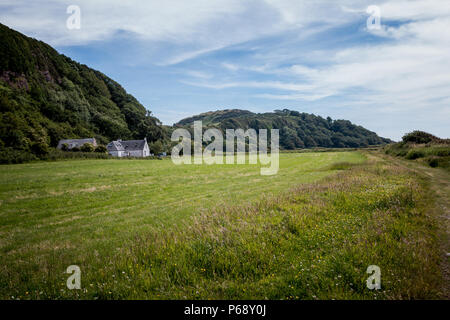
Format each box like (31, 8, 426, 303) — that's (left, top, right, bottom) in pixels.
(2, 154, 441, 299)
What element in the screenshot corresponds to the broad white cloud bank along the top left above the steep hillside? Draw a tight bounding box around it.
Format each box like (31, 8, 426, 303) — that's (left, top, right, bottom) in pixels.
(0, 0, 370, 65)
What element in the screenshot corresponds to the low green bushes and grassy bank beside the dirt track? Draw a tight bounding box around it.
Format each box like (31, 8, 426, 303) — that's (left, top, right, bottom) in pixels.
(384, 131, 450, 169)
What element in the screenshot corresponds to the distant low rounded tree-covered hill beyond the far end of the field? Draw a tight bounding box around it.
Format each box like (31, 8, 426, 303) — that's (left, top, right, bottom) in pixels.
(174, 109, 392, 149)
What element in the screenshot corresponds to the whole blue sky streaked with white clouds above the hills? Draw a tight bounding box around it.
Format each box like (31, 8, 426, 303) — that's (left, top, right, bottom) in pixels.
(0, 0, 450, 140)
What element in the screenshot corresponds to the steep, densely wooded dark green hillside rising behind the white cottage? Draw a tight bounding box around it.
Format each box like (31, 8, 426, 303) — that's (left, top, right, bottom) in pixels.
(0, 24, 165, 162)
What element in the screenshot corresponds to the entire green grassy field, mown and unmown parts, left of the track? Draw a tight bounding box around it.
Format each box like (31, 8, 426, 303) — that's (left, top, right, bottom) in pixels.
(0, 152, 442, 299)
